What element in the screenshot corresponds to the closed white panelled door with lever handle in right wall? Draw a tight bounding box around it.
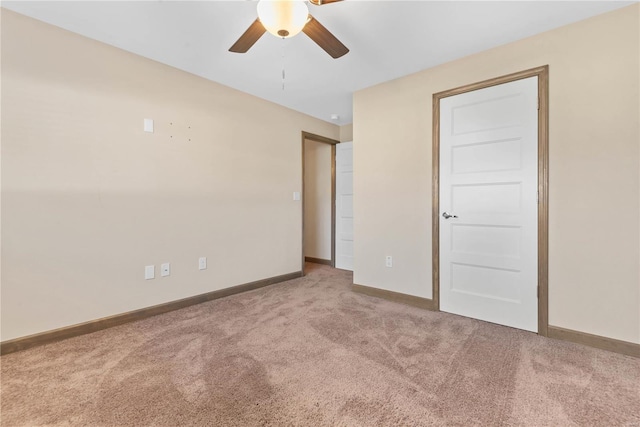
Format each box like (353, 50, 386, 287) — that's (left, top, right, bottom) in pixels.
(439, 77, 538, 332)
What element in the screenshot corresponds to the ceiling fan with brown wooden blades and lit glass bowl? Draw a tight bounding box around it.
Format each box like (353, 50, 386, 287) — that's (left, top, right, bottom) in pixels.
(229, 0, 349, 58)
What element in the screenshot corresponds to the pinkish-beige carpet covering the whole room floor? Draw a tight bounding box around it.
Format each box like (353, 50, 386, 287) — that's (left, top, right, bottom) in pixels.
(0, 264, 640, 427)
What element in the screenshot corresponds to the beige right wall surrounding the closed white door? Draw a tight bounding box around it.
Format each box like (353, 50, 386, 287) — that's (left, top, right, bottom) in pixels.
(353, 4, 640, 343)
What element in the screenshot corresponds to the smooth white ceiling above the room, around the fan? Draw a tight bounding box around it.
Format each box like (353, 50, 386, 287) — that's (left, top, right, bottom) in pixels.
(2, 0, 632, 124)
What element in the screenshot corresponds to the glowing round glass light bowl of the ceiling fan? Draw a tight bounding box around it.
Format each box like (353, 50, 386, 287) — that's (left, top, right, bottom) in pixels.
(258, 0, 309, 38)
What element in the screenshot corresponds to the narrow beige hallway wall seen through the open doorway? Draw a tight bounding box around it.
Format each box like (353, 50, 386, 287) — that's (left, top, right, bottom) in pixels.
(304, 139, 331, 260)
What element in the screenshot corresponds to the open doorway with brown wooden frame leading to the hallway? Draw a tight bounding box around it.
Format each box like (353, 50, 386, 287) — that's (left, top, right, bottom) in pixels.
(302, 132, 340, 274)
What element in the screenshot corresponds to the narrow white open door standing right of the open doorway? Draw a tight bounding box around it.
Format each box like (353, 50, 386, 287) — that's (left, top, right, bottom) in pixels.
(336, 142, 353, 271)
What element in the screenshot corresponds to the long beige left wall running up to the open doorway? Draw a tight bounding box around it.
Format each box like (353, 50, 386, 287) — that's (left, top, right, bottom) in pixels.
(1, 10, 339, 340)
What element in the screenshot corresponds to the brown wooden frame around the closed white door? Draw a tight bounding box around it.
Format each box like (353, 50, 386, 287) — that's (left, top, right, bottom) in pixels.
(431, 65, 549, 336)
